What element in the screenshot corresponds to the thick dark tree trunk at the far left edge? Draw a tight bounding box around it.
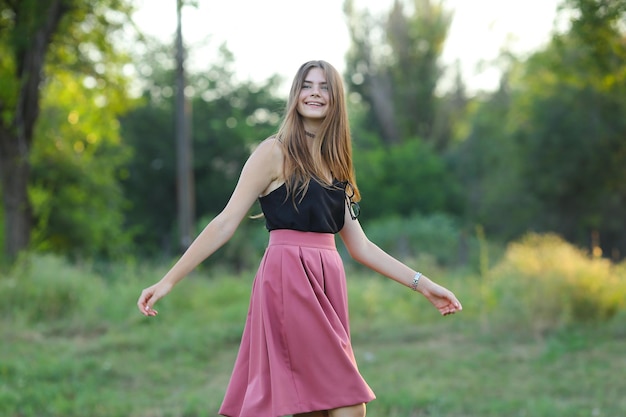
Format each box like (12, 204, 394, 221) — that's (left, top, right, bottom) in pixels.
(0, 0, 69, 260)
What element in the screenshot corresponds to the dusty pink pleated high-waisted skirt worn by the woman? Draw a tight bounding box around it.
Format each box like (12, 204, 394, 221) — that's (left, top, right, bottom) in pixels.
(219, 230, 375, 417)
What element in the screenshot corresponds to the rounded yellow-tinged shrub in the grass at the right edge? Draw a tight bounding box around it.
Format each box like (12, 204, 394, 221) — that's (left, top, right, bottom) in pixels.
(488, 234, 626, 334)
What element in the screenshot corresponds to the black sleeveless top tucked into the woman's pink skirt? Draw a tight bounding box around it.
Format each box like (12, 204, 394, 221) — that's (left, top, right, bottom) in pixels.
(259, 179, 346, 233)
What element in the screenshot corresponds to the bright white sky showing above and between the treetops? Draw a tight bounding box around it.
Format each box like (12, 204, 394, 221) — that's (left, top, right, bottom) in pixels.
(135, 0, 557, 89)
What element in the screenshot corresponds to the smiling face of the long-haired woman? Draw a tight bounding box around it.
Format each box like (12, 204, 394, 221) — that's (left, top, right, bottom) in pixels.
(298, 67, 330, 123)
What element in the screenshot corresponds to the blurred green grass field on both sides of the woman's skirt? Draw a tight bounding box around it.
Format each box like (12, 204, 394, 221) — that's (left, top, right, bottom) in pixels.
(0, 237, 626, 417)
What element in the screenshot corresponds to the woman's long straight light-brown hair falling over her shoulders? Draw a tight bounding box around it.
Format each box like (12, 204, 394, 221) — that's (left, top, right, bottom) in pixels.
(277, 61, 360, 201)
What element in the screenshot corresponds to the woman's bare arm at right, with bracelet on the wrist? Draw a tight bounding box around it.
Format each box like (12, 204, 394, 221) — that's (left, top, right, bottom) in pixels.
(339, 210, 463, 315)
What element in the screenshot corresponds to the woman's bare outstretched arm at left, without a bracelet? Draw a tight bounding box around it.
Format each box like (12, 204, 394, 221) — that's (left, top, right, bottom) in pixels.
(137, 138, 283, 316)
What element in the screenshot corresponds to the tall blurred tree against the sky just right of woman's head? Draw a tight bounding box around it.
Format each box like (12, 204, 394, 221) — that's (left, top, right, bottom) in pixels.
(344, 0, 451, 144)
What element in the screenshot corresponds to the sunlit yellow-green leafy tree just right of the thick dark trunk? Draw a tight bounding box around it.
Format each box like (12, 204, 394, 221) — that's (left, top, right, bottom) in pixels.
(29, 70, 130, 257)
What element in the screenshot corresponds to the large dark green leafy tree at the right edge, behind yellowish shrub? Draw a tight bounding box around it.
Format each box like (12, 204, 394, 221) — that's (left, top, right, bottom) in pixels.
(515, 0, 626, 256)
